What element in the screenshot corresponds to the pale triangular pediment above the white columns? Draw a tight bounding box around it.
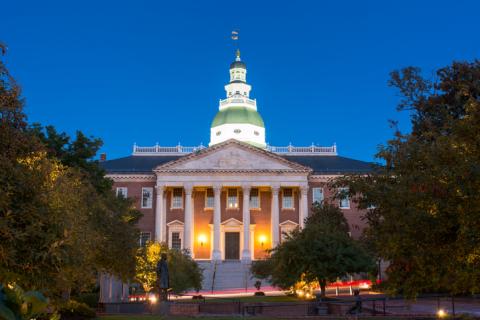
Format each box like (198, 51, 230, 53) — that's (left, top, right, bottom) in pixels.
(155, 140, 310, 172)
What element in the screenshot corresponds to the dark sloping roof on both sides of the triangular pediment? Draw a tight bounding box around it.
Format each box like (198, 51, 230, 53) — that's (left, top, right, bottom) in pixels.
(100, 155, 372, 174)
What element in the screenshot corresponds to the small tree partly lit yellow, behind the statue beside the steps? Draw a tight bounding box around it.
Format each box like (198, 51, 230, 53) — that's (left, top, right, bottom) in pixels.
(136, 242, 203, 294)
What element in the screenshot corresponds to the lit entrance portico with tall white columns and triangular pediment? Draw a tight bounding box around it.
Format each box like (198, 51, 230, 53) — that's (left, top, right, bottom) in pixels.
(154, 140, 310, 263)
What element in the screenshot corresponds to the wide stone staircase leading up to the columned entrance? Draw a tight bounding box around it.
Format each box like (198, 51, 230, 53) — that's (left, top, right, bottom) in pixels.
(199, 261, 268, 292)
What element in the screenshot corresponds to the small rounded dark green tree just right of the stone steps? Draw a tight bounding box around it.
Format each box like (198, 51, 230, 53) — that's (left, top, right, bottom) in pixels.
(252, 203, 373, 297)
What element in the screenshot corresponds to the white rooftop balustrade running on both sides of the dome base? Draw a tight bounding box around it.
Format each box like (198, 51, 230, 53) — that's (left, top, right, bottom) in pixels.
(129, 144, 337, 156)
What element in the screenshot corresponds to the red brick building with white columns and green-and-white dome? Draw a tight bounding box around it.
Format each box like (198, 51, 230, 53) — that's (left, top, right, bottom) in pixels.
(102, 51, 370, 298)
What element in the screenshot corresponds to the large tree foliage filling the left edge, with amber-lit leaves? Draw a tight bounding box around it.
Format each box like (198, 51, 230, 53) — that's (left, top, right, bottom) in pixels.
(0, 45, 139, 298)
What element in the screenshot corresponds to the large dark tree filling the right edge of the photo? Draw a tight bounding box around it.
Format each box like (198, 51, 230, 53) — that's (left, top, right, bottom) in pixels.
(336, 60, 480, 297)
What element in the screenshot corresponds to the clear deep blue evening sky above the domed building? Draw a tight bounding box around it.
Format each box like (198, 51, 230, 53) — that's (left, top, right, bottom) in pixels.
(0, 0, 480, 160)
